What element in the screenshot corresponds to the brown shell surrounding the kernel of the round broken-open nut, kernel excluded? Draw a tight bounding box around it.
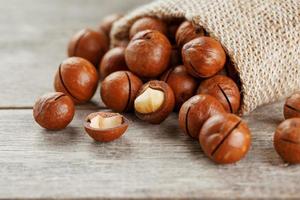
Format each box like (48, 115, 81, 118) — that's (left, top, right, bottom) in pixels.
(135, 80, 175, 124)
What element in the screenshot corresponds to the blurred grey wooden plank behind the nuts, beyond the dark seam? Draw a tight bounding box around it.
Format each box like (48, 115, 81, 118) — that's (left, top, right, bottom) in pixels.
(0, 0, 150, 107)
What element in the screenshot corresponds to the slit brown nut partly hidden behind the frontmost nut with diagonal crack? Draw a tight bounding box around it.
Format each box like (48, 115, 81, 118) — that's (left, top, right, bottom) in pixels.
(179, 94, 225, 139)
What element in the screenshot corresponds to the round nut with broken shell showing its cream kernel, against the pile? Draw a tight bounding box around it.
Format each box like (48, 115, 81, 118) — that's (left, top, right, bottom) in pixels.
(134, 80, 175, 124)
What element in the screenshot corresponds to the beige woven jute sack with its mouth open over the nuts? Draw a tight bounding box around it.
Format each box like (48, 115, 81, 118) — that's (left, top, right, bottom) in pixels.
(111, 0, 300, 114)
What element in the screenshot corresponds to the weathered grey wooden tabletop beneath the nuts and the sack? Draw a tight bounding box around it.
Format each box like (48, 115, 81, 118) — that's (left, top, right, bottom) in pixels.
(0, 0, 300, 199)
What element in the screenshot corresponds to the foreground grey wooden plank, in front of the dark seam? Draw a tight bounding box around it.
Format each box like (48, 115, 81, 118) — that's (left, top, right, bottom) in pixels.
(0, 103, 300, 198)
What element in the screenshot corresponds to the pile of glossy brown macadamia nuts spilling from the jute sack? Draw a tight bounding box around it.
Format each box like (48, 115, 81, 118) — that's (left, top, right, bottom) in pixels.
(33, 14, 300, 164)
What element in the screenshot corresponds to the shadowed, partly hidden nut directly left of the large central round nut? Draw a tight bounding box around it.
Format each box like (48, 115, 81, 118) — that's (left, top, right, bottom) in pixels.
(99, 47, 128, 79)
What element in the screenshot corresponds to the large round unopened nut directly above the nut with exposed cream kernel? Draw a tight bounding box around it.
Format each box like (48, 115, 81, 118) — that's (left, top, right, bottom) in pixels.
(125, 30, 172, 78)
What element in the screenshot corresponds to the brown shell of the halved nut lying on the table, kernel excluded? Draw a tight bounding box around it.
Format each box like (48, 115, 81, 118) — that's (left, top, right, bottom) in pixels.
(84, 112, 129, 142)
